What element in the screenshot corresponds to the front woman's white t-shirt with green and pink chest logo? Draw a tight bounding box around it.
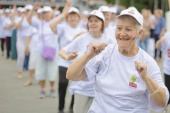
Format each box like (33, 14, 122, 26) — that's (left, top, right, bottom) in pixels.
(85, 44, 169, 113)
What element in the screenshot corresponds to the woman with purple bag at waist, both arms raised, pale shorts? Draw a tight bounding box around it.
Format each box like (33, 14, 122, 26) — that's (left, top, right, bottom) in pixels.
(27, 0, 72, 99)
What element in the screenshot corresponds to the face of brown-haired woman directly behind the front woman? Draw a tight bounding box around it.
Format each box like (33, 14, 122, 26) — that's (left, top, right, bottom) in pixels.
(88, 16, 103, 32)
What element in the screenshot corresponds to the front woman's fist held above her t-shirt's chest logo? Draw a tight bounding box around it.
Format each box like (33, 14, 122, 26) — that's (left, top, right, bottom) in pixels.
(135, 61, 147, 79)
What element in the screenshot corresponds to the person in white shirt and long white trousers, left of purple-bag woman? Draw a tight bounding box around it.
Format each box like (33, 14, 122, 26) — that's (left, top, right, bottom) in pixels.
(15, 7, 31, 78)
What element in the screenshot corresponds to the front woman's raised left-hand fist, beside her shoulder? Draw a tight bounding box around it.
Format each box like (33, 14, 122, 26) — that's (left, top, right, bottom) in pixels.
(86, 42, 107, 57)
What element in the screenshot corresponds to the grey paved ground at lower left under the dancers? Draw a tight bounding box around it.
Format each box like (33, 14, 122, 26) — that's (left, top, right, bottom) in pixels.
(0, 56, 170, 113)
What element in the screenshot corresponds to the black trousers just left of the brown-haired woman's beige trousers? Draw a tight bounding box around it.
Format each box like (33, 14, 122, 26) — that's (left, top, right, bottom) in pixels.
(58, 66, 74, 111)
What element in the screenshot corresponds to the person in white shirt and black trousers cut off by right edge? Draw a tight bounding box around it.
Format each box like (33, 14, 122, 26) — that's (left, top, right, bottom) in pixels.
(156, 32, 170, 113)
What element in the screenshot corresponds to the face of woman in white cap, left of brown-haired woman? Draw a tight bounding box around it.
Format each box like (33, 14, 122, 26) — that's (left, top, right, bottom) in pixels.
(67, 12, 80, 26)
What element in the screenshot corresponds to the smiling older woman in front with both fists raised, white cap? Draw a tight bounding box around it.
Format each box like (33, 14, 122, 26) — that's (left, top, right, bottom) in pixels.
(67, 9, 169, 113)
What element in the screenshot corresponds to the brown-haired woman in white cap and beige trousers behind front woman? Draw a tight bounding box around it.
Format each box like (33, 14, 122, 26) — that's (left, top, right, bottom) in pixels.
(59, 10, 112, 113)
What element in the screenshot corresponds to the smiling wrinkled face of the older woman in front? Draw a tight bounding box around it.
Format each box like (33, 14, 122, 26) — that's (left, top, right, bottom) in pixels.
(116, 18, 139, 49)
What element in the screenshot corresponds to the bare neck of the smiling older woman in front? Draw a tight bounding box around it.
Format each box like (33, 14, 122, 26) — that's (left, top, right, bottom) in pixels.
(119, 46, 139, 57)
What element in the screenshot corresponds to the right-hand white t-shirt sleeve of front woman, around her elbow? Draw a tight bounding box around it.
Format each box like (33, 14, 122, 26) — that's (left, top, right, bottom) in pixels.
(147, 59, 169, 112)
